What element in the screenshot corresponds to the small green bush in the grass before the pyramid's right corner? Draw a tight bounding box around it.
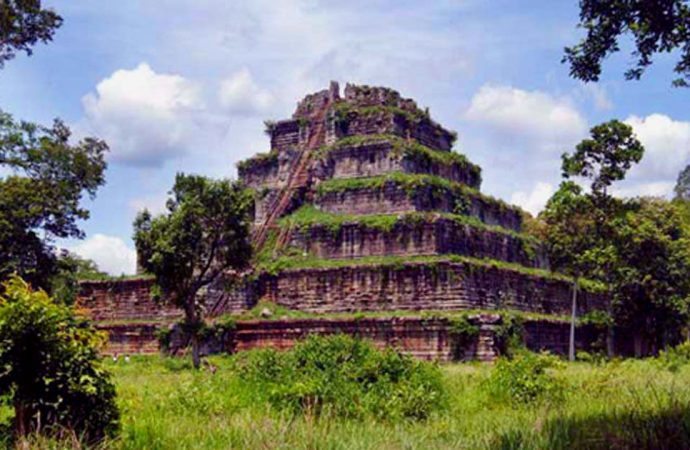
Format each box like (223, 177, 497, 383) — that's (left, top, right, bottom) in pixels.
(486, 351, 564, 405)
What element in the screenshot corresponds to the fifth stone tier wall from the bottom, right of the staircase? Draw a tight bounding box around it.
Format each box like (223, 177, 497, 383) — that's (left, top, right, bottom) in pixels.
(314, 140, 481, 188)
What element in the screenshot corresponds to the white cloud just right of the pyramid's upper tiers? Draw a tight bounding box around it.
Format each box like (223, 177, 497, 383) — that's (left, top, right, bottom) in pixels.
(464, 84, 587, 151)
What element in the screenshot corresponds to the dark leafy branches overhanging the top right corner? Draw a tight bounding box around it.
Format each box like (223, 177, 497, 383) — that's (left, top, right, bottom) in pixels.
(563, 0, 690, 86)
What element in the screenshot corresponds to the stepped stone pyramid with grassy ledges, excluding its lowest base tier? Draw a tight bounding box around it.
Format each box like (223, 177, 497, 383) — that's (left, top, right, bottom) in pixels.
(227, 82, 601, 315)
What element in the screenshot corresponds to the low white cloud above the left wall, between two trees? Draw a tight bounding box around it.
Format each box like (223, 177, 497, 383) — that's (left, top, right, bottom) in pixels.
(67, 234, 137, 275)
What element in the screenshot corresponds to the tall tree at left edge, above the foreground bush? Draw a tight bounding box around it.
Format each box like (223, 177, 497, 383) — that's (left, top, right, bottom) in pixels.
(0, 111, 108, 288)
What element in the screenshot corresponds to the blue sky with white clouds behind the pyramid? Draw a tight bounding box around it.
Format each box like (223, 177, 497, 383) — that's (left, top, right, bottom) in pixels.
(0, 0, 690, 274)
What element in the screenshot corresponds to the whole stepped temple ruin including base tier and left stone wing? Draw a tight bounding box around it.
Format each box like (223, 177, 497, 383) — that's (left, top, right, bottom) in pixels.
(80, 83, 605, 360)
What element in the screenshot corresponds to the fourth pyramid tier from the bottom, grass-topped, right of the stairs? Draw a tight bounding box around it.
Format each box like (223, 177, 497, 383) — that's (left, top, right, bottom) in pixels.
(314, 173, 522, 231)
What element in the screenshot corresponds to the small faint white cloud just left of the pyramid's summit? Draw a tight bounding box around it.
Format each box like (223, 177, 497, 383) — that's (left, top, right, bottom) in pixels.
(218, 67, 273, 113)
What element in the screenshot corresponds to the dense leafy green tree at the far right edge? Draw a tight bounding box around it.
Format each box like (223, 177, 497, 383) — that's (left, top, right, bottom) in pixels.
(612, 198, 690, 355)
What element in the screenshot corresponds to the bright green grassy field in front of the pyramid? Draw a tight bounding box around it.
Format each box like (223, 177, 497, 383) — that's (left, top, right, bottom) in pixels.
(17, 356, 690, 449)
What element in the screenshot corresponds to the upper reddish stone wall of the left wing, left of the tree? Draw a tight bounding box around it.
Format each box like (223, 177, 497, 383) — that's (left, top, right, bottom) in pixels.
(77, 278, 182, 321)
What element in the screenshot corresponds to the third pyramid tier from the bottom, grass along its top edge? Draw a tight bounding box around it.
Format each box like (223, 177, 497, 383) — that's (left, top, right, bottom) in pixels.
(281, 206, 548, 268)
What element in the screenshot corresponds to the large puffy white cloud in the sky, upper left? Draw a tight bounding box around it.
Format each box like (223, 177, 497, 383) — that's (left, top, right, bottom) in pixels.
(82, 63, 204, 166)
